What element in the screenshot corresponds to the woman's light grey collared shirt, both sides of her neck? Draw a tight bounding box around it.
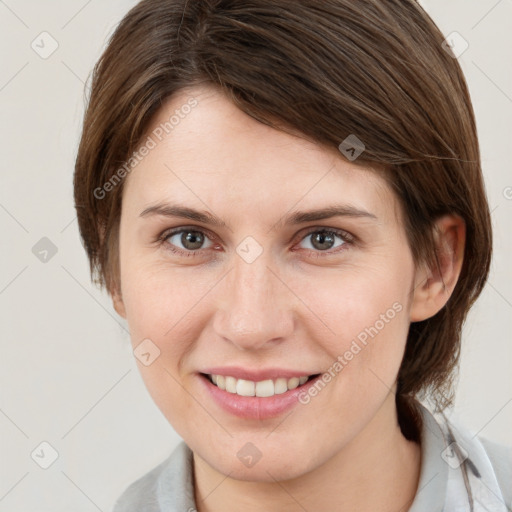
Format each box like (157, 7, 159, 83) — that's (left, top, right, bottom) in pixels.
(113, 402, 512, 512)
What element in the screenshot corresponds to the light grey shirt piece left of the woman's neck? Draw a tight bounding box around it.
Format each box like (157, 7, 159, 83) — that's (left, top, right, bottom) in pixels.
(112, 441, 193, 512)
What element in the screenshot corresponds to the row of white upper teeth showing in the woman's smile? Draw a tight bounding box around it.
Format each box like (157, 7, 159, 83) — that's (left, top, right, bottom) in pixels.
(210, 375, 309, 397)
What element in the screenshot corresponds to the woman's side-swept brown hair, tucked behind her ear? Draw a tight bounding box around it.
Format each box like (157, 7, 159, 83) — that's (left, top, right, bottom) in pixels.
(74, 0, 492, 438)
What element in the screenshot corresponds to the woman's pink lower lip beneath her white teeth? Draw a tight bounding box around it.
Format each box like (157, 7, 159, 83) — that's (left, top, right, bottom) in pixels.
(199, 374, 321, 420)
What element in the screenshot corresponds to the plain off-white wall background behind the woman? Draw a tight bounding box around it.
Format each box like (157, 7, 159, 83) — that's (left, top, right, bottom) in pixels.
(0, 0, 512, 512)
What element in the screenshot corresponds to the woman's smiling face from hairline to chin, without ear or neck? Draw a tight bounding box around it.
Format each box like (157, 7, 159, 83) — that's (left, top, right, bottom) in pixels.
(115, 87, 415, 481)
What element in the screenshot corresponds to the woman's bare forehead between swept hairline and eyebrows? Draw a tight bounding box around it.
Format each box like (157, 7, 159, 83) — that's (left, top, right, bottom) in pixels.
(123, 86, 396, 226)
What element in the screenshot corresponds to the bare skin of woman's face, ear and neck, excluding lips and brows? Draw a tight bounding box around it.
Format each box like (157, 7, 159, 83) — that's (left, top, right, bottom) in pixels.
(113, 86, 465, 512)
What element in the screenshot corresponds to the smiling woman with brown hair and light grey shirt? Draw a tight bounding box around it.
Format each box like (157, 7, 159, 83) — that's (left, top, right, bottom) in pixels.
(75, 0, 512, 512)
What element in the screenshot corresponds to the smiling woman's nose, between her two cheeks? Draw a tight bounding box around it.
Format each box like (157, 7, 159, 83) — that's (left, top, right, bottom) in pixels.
(213, 252, 297, 350)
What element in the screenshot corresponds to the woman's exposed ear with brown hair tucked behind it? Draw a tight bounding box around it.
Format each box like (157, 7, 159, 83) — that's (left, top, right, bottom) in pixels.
(410, 215, 466, 322)
